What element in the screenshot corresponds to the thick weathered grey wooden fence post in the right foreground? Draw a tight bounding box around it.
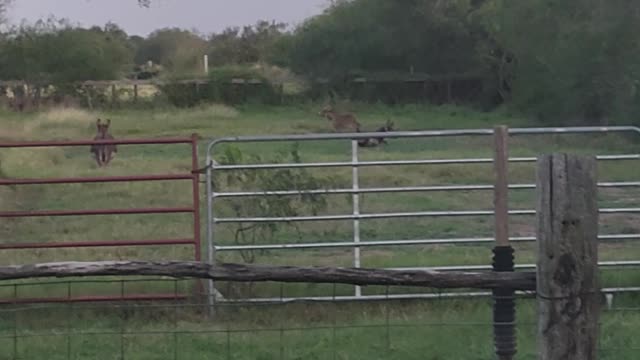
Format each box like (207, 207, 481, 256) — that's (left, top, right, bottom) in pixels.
(537, 154, 599, 360)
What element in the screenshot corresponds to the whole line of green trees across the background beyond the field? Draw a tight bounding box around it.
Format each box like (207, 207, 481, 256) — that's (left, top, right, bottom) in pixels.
(0, 0, 640, 124)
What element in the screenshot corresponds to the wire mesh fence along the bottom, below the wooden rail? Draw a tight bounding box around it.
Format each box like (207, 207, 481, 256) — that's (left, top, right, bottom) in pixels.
(0, 279, 640, 360)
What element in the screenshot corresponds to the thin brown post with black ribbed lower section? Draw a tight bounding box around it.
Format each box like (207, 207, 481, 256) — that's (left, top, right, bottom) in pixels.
(493, 126, 517, 360)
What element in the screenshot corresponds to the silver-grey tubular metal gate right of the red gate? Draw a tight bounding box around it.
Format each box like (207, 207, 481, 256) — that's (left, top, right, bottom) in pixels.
(206, 126, 640, 305)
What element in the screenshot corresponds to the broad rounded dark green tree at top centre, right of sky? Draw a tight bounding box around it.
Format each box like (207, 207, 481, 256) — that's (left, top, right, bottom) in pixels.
(284, 0, 481, 77)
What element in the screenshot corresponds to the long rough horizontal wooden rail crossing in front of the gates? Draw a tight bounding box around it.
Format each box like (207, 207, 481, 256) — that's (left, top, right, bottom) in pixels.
(0, 261, 536, 290)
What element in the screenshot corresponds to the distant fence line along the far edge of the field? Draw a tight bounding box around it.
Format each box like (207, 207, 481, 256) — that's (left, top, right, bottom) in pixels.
(0, 74, 486, 106)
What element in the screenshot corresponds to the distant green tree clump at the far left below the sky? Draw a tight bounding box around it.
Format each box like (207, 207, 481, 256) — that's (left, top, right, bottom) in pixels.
(0, 20, 132, 107)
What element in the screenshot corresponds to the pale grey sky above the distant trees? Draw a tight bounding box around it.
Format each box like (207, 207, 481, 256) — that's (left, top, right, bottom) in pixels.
(9, 0, 328, 35)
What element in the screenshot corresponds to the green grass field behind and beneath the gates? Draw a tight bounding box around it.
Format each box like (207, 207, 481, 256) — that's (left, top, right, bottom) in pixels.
(0, 104, 640, 359)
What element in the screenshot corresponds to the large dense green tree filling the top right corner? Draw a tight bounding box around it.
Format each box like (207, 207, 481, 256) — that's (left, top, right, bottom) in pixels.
(484, 0, 640, 125)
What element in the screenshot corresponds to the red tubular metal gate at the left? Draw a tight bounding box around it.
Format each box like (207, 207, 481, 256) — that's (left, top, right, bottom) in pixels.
(0, 134, 201, 304)
